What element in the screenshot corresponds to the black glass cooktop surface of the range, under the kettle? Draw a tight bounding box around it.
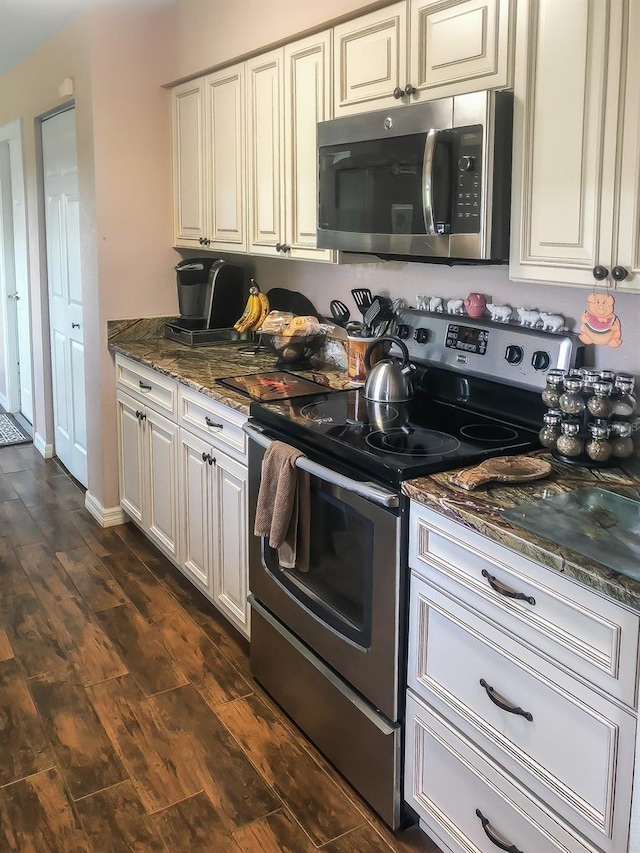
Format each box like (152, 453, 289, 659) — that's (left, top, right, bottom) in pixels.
(251, 390, 540, 485)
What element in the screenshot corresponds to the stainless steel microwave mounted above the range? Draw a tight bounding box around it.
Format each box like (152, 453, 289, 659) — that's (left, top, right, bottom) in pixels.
(318, 91, 513, 262)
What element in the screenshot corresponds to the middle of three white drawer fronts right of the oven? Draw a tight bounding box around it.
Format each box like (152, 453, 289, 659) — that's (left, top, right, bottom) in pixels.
(408, 574, 636, 851)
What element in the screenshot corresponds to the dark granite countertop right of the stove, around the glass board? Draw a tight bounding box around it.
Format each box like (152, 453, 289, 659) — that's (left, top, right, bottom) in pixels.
(402, 451, 640, 611)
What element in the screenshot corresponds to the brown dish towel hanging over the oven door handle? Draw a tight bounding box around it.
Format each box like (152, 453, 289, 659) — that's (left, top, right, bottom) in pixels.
(254, 441, 310, 572)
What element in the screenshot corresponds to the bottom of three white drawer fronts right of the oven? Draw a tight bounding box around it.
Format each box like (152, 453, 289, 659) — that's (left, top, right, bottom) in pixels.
(405, 692, 597, 853)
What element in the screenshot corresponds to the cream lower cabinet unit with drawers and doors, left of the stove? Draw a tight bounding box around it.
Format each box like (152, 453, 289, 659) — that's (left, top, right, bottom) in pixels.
(116, 356, 249, 637)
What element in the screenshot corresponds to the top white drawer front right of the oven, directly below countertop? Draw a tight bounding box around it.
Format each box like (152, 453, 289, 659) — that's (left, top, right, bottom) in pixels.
(409, 502, 638, 708)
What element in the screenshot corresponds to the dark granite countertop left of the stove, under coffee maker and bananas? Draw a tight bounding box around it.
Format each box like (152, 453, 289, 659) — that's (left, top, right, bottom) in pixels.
(107, 318, 348, 414)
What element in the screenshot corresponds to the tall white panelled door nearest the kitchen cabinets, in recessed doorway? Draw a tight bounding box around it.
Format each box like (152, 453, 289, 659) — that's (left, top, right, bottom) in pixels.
(42, 109, 87, 486)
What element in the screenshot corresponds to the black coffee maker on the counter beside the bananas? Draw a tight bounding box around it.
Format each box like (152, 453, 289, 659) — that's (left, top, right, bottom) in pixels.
(165, 258, 249, 346)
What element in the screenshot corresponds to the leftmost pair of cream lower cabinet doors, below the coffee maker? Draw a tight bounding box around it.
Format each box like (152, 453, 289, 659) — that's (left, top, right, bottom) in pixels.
(117, 389, 178, 559)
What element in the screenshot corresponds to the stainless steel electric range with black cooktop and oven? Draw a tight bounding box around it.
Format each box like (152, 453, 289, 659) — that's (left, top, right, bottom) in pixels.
(246, 309, 582, 828)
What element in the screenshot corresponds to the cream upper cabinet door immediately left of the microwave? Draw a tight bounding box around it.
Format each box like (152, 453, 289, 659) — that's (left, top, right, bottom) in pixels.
(284, 33, 334, 261)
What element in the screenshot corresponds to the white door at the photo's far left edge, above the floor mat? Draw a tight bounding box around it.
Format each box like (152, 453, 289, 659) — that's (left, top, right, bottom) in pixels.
(0, 121, 33, 423)
